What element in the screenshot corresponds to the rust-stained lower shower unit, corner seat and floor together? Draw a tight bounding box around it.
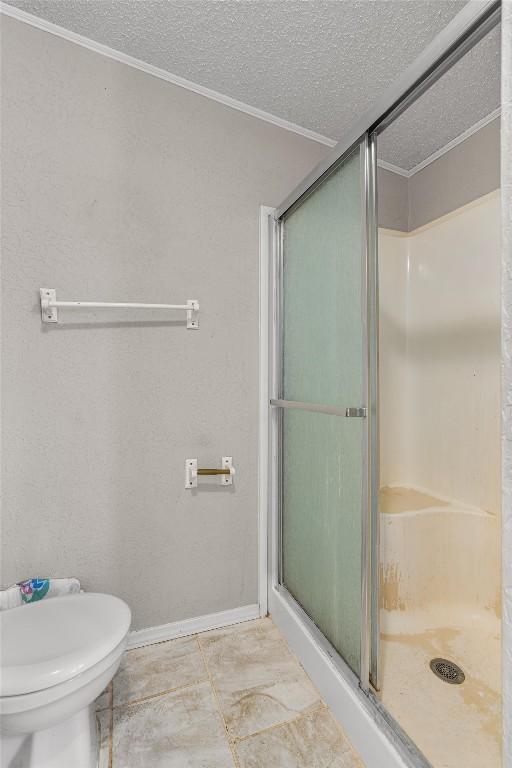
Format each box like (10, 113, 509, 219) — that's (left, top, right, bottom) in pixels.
(379, 488, 501, 768)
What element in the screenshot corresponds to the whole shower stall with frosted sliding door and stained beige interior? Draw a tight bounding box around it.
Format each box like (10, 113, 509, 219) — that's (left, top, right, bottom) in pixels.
(262, 2, 501, 768)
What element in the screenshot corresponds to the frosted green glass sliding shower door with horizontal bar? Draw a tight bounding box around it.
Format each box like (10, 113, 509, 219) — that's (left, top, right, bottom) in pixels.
(272, 144, 367, 676)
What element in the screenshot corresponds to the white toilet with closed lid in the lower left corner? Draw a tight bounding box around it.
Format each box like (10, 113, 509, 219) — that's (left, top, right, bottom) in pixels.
(0, 593, 131, 768)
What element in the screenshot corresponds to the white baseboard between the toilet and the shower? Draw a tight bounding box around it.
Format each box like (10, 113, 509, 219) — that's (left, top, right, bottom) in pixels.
(128, 604, 260, 650)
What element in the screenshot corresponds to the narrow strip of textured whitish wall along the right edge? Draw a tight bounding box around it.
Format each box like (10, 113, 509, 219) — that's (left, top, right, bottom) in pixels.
(501, 0, 512, 768)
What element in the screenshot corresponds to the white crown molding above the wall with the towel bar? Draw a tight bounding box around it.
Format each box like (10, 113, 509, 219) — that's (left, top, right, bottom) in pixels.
(0, 2, 337, 147)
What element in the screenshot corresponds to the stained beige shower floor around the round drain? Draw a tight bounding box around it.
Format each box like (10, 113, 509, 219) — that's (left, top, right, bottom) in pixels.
(380, 617, 501, 768)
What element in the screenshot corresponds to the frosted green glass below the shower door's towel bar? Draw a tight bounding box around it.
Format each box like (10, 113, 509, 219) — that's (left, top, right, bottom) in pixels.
(281, 410, 364, 674)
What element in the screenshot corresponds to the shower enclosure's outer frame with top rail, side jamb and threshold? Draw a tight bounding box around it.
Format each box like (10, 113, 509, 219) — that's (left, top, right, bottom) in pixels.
(260, 0, 501, 768)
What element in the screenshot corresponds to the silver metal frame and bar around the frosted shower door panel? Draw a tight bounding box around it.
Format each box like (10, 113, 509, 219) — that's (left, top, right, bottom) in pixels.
(269, 132, 378, 691)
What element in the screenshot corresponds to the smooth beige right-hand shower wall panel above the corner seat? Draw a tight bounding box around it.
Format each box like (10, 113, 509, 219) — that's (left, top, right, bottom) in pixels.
(406, 193, 500, 514)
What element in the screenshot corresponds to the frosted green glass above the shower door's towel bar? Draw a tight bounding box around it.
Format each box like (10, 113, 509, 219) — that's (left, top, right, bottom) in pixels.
(282, 150, 363, 408)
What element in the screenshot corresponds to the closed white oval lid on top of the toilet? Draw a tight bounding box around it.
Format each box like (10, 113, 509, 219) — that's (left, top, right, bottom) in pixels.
(0, 592, 131, 696)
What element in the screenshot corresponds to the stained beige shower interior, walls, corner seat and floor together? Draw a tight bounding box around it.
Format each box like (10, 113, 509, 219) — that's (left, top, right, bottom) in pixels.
(379, 184, 502, 768)
